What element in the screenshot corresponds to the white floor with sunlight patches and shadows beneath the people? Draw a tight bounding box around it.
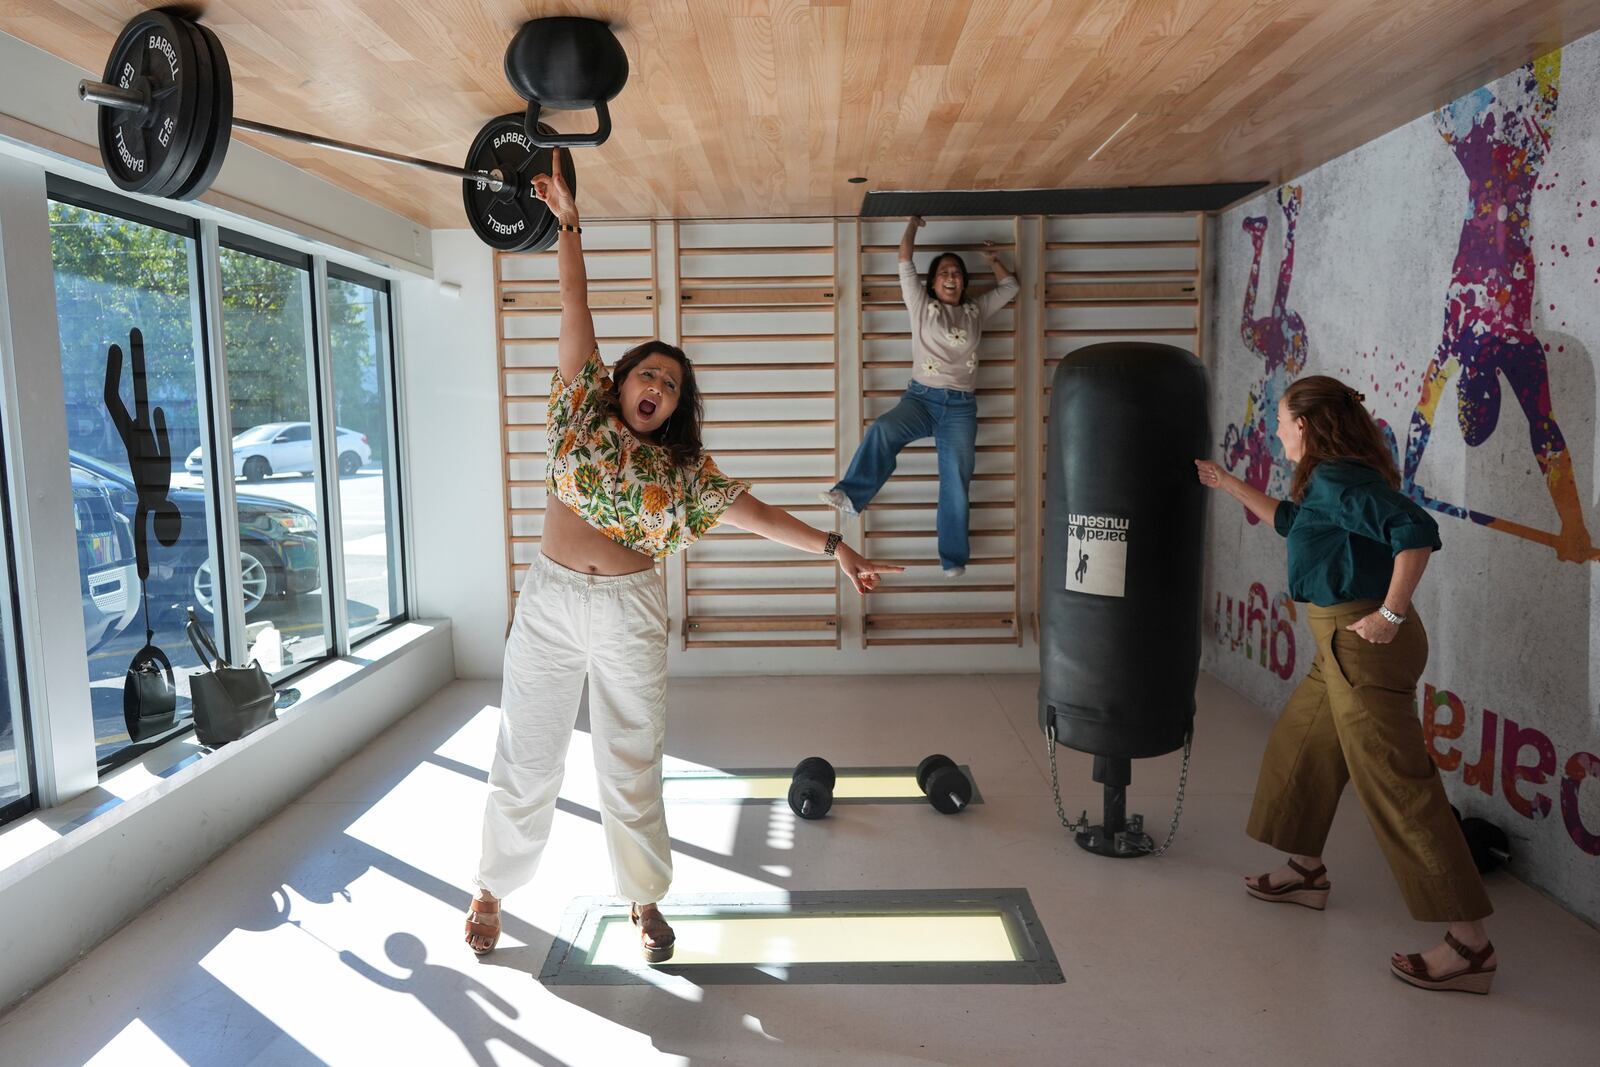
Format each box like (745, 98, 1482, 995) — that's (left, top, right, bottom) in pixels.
(0, 675, 1600, 1067)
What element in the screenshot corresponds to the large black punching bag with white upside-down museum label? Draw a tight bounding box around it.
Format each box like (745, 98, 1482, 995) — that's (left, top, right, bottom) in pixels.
(1038, 342, 1211, 843)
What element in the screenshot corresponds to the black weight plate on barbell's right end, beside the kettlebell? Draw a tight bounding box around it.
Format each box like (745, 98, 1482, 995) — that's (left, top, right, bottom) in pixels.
(461, 114, 578, 251)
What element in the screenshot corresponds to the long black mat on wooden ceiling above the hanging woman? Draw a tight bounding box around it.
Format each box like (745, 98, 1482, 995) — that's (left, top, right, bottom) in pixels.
(861, 181, 1267, 219)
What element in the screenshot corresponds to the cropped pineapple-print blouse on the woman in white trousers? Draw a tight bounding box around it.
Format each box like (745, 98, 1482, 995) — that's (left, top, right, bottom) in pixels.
(544, 349, 750, 560)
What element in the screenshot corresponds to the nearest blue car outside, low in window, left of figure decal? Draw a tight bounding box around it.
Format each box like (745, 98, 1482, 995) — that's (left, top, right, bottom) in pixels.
(72, 464, 139, 653)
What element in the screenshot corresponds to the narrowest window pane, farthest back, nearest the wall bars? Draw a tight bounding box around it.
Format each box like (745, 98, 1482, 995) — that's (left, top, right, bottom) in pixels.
(328, 272, 403, 640)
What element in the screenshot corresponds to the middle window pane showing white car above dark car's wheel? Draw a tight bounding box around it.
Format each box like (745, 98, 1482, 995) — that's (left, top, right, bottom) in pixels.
(217, 237, 331, 675)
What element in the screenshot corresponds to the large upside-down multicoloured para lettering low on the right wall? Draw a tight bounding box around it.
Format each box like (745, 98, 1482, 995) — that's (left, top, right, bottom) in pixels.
(1422, 685, 1600, 856)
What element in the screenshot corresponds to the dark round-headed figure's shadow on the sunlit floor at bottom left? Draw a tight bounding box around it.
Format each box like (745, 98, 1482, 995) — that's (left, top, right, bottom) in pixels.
(339, 931, 562, 1067)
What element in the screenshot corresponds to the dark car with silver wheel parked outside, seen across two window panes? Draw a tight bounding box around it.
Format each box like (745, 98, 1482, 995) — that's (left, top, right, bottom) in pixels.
(72, 453, 322, 616)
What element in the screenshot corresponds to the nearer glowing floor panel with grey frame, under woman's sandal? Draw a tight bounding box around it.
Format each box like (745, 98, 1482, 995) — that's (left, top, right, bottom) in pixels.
(539, 889, 1061, 985)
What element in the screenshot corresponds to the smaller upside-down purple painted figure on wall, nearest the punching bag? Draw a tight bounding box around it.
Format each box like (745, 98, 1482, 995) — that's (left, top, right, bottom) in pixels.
(1222, 186, 1306, 525)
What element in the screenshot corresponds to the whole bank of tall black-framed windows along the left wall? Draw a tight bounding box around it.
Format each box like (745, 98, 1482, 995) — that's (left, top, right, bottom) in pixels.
(20, 178, 406, 780)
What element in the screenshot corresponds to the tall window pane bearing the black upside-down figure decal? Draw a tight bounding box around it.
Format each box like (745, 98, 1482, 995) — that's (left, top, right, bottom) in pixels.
(50, 200, 216, 765)
